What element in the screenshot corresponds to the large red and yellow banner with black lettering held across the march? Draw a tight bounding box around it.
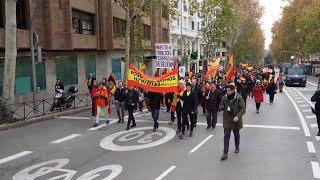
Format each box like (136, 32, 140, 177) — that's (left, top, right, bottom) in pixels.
(128, 64, 179, 93)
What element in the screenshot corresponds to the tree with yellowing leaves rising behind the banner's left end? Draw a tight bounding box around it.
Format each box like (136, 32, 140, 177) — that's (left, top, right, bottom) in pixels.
(119, 0, 172, 82)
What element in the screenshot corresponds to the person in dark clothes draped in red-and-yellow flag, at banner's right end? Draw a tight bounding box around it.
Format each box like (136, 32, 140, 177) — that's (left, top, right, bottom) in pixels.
(169, 80, 186, 135)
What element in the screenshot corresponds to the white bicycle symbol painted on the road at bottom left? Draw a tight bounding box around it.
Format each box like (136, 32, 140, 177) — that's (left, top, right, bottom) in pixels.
(13, 159, 123, 180)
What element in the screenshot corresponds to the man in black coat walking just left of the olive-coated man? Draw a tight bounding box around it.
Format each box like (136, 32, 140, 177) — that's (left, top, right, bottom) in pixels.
(204, 83, 221, 130)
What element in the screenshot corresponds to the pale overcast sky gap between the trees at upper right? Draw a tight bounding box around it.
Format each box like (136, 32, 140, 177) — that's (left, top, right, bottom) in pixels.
(259, 0, 288, 49)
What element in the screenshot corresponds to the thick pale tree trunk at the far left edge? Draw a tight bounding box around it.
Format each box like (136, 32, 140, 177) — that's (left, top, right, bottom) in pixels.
(2, 0, 17, 122)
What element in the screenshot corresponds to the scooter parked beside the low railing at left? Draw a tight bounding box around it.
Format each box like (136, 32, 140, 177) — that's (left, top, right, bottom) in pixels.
(50, 86, 78, 111)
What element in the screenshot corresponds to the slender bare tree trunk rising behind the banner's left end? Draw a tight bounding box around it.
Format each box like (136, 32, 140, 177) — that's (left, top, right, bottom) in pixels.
(123, 7, 131, 85)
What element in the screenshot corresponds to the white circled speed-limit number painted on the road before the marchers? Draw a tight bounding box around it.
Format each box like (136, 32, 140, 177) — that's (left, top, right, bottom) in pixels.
(100, 127, 176, 151)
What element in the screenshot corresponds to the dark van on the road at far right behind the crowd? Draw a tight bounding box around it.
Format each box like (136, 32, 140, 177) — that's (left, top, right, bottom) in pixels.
(286, 67, 307, 87)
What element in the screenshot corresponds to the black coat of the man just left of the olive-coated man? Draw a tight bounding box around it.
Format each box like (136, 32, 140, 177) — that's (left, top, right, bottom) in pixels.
(204, 89, 222, 111)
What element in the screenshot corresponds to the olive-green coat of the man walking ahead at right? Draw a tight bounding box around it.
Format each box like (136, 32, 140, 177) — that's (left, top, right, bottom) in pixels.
(221, 93, 246, 129)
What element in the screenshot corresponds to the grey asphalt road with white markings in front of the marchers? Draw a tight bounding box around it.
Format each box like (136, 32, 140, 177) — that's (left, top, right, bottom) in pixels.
(0, 80, 320, 180)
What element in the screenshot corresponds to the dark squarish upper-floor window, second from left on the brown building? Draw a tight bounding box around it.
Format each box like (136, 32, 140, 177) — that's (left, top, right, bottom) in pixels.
(72, 10, 94, 35)
